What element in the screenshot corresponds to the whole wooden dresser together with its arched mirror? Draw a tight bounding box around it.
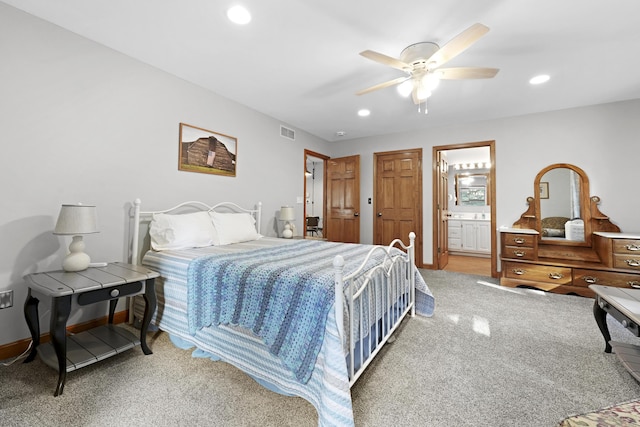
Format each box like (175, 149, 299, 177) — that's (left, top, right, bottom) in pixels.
(500, 163, 640, 297)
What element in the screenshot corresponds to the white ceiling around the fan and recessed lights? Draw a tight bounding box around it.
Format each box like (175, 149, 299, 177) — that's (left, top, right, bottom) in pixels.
(4, 0, 640, 141)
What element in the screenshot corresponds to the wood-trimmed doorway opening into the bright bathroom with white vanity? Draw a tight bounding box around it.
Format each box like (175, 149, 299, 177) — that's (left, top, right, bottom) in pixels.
(433, 141, 498, 277)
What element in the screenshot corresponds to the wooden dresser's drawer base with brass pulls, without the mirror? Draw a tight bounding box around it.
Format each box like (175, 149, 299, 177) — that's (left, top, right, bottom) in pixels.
(500, 228, 640, 297)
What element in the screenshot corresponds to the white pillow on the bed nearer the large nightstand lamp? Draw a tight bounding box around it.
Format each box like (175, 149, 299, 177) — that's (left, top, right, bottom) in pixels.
(149, 212, 218, 251)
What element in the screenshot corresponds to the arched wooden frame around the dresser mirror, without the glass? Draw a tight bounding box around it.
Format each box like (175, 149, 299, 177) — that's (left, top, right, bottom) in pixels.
(533, 163, 592, 247)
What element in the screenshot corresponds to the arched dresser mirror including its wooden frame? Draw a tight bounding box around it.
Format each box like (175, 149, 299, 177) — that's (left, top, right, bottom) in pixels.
(534, 163, 591, 245)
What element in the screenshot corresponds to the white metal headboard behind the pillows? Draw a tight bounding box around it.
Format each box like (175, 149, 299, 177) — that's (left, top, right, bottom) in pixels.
(129, 199, 262, 264)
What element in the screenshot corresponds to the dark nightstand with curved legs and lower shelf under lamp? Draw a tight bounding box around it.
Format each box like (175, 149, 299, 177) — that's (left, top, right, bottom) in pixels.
(24, 262, 159, 396)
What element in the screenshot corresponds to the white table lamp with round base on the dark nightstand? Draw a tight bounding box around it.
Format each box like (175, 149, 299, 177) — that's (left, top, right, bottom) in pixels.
(53, 204, 98, 271)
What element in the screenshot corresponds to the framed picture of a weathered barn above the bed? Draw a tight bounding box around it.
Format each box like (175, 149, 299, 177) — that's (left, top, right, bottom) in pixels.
(178, 123, 238, 177)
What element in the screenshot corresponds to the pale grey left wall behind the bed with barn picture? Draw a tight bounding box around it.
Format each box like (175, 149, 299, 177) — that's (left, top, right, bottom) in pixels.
(0, 3, 327, 345)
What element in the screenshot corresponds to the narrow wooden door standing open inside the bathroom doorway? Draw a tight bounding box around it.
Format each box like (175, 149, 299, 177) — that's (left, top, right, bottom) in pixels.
(436, 151, 449, 270)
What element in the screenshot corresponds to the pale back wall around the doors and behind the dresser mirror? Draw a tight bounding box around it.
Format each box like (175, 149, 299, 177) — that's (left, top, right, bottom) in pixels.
(331, 99, 640, 264)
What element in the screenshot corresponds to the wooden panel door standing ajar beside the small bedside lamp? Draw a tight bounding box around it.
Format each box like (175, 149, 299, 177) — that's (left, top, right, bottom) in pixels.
(323, 156, 360, 243)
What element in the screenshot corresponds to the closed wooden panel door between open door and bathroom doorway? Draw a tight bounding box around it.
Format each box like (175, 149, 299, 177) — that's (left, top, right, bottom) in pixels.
(373, 149, 422, 267)
